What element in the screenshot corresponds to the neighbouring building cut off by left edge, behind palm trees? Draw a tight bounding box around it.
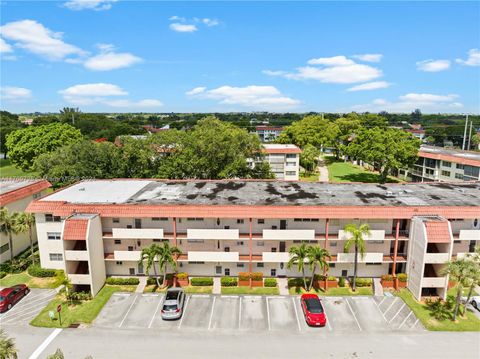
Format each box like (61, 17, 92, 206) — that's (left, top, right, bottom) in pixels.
(0, 178, 51, 263)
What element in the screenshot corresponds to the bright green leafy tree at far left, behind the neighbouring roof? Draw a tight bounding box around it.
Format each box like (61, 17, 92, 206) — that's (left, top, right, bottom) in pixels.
(7, 123, 83, 171)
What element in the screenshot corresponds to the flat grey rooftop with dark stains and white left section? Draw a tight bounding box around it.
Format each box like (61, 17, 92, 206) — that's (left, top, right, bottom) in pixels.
(40, 179, 480, 207)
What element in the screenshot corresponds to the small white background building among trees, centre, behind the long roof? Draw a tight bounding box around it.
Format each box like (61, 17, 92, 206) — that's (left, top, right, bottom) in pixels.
(263, 144, 302, 181)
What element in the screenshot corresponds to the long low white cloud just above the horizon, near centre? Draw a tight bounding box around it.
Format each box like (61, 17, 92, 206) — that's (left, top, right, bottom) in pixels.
(187, 85, 300, 110)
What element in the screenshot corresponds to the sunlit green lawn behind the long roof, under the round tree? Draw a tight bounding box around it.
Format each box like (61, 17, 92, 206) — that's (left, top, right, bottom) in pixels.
(325, 156, 399, 183)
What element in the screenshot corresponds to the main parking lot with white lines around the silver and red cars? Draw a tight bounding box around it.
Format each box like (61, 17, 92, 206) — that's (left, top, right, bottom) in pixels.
(93, 293, 423, 333)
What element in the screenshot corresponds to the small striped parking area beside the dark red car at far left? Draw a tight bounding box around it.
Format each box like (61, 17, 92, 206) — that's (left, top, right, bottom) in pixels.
(0, 288, 57, 326)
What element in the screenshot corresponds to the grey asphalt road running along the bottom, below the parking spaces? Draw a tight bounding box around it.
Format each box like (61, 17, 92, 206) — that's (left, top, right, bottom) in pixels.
(5, 326, 480, 359)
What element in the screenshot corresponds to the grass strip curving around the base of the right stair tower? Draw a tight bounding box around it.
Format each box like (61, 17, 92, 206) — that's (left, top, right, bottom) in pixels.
(395, 289, 480, 332)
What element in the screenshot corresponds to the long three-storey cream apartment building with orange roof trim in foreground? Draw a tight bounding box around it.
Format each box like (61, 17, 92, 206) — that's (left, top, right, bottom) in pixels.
(28, 179, 480, 298)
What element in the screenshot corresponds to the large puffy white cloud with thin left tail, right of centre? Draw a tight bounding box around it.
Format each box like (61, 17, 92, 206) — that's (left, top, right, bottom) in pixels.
(263, 56, 383, 84)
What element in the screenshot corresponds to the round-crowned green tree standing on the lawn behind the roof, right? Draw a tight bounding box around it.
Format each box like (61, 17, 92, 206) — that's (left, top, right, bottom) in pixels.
(347, 127, 421, 183)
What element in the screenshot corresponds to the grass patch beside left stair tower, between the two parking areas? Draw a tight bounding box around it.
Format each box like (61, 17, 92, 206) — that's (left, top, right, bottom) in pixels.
(30, 285, 137, 328)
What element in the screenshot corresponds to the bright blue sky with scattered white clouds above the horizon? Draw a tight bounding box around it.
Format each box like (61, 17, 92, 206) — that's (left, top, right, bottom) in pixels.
(0, 0, 480, 113)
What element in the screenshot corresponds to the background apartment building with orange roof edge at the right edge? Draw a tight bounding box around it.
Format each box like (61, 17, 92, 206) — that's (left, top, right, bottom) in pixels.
(401, 146, 480, 182)
